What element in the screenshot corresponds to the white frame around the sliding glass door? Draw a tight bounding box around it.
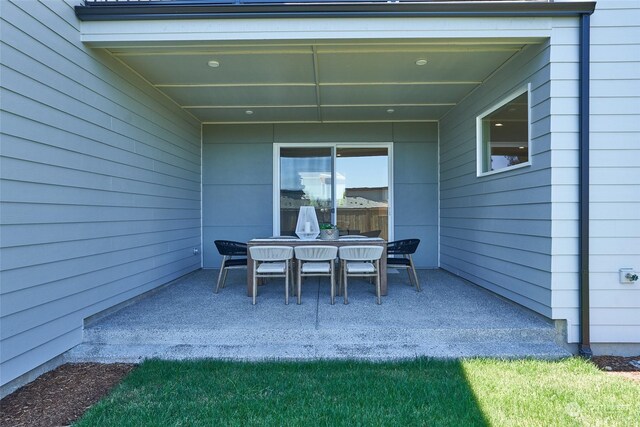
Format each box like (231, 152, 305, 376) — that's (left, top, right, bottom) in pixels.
(272, 142, 395, 241)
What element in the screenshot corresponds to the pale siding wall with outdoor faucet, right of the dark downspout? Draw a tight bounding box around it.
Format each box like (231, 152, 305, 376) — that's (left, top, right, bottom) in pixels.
(590, 0, 640, 354)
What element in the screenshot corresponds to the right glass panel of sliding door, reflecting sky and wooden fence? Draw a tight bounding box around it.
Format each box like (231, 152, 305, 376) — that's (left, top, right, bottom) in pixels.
(336, 147, 389, 240)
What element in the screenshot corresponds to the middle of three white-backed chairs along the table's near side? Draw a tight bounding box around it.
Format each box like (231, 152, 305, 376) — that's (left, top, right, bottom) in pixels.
(295, 245, 338, 304)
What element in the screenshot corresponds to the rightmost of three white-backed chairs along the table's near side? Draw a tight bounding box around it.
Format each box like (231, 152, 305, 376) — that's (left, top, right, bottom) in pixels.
(338, 245, 384, 304)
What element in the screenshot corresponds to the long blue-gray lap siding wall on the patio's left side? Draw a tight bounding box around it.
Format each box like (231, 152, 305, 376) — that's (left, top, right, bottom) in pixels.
(0, 0, 201, 388)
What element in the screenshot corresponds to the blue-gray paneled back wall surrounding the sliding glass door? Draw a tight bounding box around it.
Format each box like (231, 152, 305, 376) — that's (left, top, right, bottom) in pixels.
(203, 123, 438, 268)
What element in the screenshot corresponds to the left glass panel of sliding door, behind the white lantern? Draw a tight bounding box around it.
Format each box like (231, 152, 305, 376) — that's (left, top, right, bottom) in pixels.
(280, 147, 333, 236)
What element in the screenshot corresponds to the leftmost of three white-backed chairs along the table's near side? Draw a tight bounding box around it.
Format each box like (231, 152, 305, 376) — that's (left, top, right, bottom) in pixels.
(249, 246, 293, 304)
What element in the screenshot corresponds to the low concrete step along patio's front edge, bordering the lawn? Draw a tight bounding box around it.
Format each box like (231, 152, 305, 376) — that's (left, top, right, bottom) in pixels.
(66, 328, 570, 363)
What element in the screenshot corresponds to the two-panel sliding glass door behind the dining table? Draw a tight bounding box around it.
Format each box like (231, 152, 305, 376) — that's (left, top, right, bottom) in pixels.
(274, 144, 391, 239)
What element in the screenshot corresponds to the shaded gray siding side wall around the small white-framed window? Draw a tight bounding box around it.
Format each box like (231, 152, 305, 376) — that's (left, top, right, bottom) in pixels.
(440, 40, 563, 317)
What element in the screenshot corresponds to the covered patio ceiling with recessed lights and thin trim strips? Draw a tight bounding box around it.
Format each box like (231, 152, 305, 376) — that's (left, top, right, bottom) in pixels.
(109, 39, 530, 123)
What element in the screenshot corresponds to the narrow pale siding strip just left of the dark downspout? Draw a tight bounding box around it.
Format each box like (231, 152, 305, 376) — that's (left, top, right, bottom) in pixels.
(549, 9, 580, 348)
